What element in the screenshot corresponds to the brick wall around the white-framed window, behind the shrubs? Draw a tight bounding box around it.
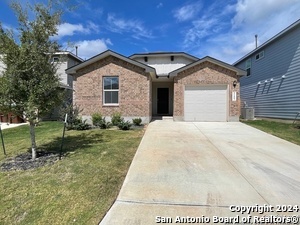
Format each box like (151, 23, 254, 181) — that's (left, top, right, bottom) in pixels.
(73, 56, 151, 122)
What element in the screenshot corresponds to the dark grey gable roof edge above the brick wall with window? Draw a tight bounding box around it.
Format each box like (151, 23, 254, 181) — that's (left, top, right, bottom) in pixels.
(66, 50, 155, 74)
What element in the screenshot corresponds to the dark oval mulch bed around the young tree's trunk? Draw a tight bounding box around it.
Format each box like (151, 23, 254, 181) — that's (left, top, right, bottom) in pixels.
(0, 151, 59, 171)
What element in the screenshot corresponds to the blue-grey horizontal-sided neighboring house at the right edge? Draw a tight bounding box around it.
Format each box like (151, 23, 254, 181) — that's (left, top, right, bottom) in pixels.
(233, 20, 300, 119)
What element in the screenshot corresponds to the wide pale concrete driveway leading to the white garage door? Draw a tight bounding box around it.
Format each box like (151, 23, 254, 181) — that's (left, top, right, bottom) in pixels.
(100, 121, 300, 225)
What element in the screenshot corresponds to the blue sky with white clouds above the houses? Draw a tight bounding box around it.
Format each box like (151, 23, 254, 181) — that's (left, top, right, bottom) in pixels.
(0, 0, 300, 64)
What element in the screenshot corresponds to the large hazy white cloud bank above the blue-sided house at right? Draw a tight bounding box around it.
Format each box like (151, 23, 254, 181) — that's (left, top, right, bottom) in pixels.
(183, 0, 300, 63)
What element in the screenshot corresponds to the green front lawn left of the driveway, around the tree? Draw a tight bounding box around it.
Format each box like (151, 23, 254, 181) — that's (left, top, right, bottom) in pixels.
(0, 122, 143, 225)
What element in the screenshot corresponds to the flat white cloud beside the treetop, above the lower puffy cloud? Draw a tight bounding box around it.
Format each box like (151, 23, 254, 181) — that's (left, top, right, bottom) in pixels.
(57, 21, 99, 38)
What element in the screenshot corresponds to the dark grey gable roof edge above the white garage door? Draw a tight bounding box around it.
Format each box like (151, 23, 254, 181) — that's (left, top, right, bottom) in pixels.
(169, 56, 246, 77)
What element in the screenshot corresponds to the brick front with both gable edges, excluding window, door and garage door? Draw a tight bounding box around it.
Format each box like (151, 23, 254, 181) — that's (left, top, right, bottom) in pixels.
(67, 50, 246, 123)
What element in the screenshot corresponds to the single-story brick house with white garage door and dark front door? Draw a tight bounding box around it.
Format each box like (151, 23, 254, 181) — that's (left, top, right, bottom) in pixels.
(66, 50, 246, 123)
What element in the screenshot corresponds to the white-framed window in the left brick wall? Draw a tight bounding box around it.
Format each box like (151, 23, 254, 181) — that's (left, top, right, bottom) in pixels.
(103, 77, 119, 105)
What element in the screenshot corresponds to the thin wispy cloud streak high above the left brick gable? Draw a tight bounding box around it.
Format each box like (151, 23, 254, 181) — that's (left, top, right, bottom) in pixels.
(107, 14, 153, 39)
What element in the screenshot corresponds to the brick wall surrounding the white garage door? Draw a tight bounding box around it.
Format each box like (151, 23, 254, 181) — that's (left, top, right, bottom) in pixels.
(174, 62, 240, 121)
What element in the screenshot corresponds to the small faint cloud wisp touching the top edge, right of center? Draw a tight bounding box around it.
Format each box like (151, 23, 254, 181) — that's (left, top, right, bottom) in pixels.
(173, 2, 202, 22)
